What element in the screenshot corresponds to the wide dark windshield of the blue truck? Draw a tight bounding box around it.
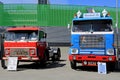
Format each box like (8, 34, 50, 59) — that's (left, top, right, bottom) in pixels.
(72, 20, 112, 32)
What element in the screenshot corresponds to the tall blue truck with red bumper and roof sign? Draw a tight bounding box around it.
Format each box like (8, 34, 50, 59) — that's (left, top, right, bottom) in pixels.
(68, 9, 117, 69)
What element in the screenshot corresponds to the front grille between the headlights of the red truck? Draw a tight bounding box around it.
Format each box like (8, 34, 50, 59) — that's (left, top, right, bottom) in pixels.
(10, 48, 29, 56)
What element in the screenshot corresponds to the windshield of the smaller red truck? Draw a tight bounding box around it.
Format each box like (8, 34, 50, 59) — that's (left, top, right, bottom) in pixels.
(5, 31, 38, 41)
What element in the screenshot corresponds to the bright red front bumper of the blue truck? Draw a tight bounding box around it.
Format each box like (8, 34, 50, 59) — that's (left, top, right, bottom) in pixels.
(69, 55, 116, 66)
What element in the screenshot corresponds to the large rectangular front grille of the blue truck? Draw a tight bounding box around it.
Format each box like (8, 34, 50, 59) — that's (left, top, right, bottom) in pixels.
(80, 35, 105, 48)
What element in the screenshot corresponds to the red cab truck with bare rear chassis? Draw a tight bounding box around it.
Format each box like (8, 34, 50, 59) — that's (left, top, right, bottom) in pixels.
(1, 26, 61, 69)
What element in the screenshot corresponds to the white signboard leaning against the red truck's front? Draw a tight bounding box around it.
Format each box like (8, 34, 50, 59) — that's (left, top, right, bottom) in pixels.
(7, 57, 18, 70)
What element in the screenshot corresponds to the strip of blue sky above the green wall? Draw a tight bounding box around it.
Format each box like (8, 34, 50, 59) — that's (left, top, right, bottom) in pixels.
(0, 0, 120, 7)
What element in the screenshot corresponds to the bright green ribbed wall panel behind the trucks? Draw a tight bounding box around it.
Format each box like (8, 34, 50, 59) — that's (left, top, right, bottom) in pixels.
(0, 4, 120, 27)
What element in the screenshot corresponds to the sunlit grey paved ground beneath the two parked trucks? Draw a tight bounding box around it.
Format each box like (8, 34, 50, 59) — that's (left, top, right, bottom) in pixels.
(0, 47, 120, 80)
